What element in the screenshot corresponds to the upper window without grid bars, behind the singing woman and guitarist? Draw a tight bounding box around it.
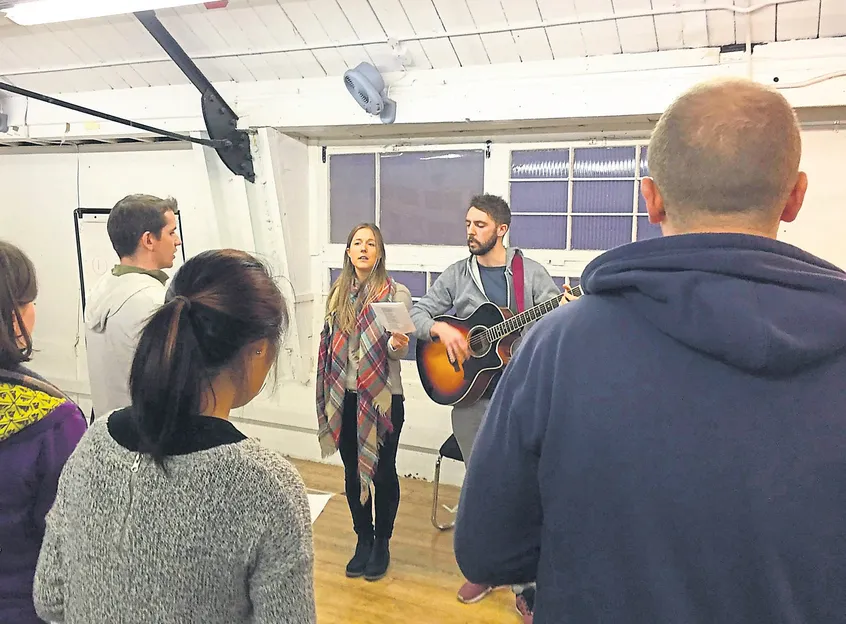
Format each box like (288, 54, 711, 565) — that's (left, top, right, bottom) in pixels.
(329, 149, 485, 245)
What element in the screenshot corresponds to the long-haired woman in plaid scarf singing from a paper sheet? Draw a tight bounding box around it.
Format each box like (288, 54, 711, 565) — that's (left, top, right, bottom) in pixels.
(316, 224, 411, 581)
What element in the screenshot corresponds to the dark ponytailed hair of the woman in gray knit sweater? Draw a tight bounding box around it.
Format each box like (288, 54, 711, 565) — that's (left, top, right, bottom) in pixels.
(129, 249, 288, 465)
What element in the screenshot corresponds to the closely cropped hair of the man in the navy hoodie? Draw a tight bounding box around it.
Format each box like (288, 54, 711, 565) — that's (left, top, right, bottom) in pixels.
(648, 79, 802, 223)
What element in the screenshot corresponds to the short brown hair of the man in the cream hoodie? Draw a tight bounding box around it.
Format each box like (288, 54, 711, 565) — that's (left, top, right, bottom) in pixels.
(106, 195, 179, 258)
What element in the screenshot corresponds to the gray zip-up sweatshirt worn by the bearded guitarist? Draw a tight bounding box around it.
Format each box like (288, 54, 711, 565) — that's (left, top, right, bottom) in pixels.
(411, 247, 563, 340)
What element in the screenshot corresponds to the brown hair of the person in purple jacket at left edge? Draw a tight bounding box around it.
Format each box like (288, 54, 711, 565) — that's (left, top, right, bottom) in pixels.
(0, 241, 38, 370)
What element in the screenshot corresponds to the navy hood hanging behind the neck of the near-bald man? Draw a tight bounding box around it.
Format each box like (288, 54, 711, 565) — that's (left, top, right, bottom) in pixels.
(582, 234, 846, 375)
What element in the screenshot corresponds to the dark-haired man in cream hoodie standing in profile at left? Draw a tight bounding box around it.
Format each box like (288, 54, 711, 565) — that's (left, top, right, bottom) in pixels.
(85, 195, 182, 417)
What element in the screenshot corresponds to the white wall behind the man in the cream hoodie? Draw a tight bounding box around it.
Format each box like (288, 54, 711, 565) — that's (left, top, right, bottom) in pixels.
(0, 145, 222, 404)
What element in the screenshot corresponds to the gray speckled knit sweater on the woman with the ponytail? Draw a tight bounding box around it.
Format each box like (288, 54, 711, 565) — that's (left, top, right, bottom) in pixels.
(34, 412, 316, 624)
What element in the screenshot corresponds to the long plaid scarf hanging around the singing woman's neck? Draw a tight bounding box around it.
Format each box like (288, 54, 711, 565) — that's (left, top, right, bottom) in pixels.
(315, 278, 396, 503)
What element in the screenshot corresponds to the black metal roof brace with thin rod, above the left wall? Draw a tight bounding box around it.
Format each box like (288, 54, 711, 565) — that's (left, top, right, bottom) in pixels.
(0, 11, 256, 182)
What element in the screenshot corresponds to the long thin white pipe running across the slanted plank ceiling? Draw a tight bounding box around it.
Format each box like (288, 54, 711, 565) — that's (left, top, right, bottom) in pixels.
(2, 0, 806, 78)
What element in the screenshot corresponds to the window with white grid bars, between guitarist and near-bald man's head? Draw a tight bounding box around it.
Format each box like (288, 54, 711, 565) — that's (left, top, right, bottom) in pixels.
(510, 146, 660, 251)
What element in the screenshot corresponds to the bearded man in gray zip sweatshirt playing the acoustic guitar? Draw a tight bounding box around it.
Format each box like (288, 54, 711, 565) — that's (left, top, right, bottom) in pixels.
(411, 195, 562, 603)
